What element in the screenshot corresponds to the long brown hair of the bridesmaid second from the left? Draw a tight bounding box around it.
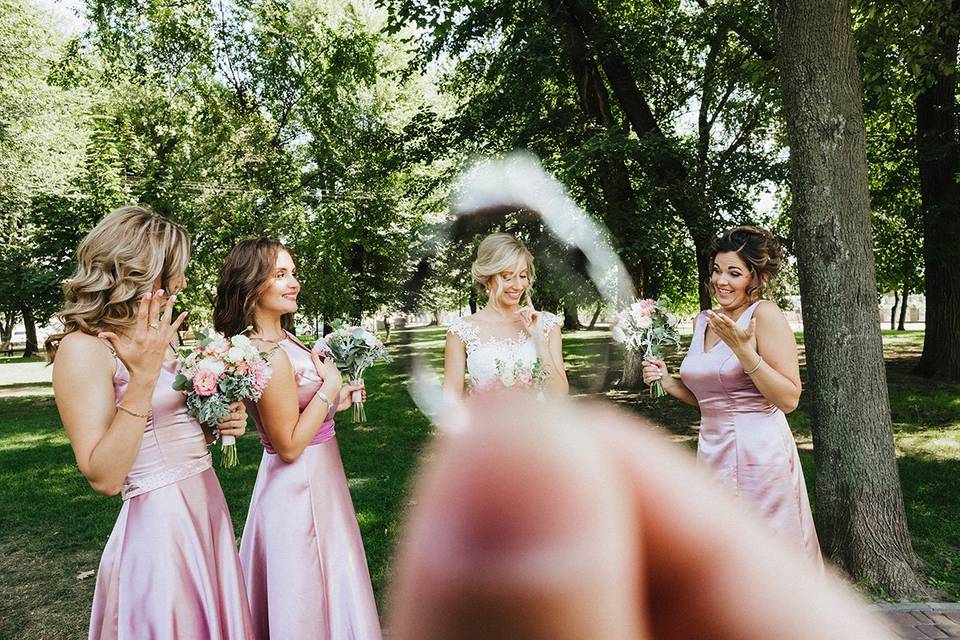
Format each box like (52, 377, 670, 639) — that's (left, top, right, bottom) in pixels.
(213, 237, 293, 338)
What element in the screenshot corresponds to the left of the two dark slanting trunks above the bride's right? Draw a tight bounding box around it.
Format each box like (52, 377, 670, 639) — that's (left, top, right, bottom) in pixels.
(544, 0, 651, 295)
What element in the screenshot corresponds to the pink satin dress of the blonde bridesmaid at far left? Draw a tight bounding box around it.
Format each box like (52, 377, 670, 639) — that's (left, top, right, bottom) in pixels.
(89, 352, 253, 640)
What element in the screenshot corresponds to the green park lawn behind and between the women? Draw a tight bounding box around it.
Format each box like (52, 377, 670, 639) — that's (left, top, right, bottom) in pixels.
(0, 328, 960, 640)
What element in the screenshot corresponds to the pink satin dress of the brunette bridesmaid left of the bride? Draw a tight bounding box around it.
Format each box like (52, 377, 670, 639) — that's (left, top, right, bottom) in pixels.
(240, 337, 381, 640)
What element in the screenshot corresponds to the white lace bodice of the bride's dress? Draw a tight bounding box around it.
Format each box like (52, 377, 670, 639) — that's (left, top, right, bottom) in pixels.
(447, 311, 563, 390)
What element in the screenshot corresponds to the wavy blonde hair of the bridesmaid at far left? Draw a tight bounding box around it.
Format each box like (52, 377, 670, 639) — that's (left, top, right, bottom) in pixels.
(45, 206, 190, 362)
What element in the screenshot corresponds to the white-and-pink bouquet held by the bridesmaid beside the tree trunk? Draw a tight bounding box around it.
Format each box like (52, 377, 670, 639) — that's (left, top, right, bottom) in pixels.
(612, 298, 680, 398)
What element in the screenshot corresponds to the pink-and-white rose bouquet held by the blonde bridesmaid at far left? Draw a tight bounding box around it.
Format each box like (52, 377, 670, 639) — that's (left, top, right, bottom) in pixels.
(173, 329, 271, 468)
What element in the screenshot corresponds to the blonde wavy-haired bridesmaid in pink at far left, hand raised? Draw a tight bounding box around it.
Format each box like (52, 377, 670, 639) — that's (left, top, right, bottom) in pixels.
(47, 207, 252, 639)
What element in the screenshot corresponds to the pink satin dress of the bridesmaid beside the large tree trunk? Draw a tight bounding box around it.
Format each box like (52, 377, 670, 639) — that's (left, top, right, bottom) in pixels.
(680, 302, 823, 567)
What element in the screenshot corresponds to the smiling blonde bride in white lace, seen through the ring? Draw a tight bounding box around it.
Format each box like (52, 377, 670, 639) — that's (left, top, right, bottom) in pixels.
(443, 233, 569, 398)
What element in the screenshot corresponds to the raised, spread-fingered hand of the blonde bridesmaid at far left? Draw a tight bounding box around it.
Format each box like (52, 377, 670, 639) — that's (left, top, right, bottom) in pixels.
(97, 289, 187, 384)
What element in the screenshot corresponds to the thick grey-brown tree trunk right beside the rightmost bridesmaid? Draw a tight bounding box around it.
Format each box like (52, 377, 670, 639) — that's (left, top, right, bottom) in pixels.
(770, 0, 926, 597)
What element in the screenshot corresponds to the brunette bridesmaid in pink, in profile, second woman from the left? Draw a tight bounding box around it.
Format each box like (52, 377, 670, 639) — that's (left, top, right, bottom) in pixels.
(214, 238, 380, 640)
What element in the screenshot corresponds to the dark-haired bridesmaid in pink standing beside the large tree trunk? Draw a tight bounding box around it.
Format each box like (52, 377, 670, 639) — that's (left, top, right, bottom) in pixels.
(643, 227, 823, 566)
